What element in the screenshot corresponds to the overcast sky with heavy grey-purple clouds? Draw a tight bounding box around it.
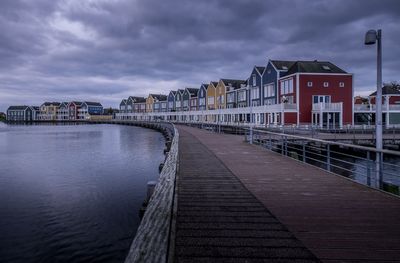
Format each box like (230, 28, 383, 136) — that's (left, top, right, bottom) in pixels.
(0, 0, 400, 111)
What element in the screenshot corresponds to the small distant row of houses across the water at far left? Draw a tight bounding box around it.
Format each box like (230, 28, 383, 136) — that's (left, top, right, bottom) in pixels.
(7, 101, 103, 121)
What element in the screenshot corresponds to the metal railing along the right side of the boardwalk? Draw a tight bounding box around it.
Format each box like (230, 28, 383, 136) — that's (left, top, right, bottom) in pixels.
(245, 129, 400, 195)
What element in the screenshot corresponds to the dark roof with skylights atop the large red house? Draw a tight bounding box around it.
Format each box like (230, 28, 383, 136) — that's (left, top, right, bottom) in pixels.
(286, 60, 347, 75)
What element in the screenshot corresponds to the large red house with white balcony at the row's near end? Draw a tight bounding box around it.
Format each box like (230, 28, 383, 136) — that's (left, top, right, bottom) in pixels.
(278, 60, 353, 127)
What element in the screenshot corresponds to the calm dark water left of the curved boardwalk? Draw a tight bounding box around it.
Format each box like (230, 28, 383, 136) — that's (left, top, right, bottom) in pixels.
(0, 123, 164, 262)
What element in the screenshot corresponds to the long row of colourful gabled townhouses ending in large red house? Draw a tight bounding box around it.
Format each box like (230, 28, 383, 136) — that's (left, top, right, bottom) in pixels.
(117, 60, 353, 130)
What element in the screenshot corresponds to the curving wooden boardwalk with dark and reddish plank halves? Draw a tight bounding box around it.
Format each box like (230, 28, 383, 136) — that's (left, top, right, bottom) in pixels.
(174, 126, 400, 262)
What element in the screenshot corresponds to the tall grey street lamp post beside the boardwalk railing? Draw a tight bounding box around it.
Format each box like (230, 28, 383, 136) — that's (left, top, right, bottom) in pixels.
(365, 29, 383, 188)
